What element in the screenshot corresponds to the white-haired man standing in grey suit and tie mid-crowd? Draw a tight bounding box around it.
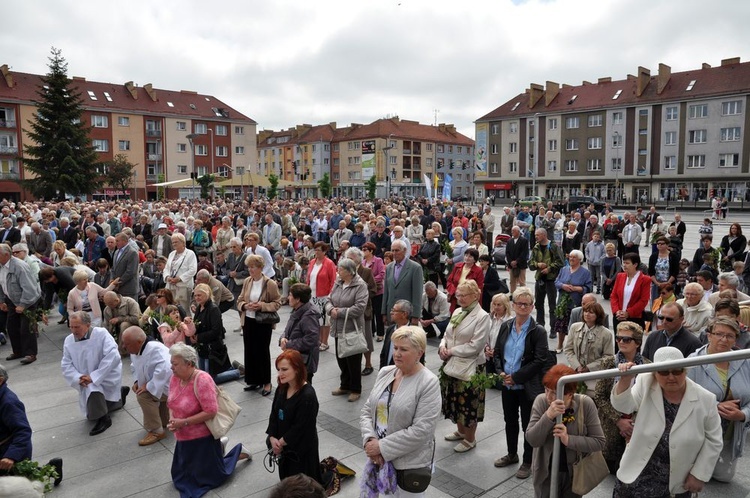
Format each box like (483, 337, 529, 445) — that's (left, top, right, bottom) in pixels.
(380, 240, 424, 325)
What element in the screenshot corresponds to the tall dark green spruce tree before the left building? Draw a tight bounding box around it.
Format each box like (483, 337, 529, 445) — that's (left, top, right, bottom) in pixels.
(19, 47, 102, 199)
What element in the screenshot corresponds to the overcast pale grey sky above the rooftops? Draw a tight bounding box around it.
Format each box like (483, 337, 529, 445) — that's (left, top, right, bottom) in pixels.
(0, 0, 750, 138)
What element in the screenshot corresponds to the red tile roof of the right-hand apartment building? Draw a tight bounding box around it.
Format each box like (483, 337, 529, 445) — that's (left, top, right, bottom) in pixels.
(477, 57, 750, 121)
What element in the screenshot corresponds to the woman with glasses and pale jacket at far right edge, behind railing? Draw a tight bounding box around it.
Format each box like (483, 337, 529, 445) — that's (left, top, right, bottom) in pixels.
(688, 316, 750, 482)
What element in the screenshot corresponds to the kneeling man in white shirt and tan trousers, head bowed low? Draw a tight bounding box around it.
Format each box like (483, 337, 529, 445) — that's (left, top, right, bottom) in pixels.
(122, 327, 172, 446)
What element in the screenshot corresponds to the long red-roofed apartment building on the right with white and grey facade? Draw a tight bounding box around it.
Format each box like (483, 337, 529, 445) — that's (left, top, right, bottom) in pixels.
(476, 58, 750, 203)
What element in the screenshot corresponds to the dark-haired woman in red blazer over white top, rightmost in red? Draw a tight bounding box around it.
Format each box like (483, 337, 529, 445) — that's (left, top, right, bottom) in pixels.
(609, 252, 651, 330)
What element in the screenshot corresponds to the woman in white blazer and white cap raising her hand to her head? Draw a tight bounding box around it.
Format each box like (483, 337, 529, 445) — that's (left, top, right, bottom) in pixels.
(610, 346, 723, 498)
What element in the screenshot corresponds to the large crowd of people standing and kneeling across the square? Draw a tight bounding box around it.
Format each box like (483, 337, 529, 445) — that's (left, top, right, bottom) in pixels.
(0, 198, 750, 496)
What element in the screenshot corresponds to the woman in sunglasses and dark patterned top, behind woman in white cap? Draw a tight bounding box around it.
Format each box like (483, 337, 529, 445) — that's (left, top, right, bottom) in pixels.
(592, 321, 651, 474)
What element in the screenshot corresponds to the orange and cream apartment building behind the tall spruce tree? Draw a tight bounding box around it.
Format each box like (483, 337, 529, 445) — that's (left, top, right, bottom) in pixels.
(0, 65, 257, 199)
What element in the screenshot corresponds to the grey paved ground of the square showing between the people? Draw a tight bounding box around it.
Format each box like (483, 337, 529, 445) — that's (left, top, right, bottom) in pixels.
(10, 211, 750, 498)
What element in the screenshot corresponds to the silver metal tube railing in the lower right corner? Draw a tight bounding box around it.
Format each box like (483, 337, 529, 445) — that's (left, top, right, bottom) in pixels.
(550, 349, 750, 498)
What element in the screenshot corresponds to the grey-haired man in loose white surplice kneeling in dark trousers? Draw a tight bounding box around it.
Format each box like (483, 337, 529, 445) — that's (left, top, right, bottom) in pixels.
(61, 311, 130, 436)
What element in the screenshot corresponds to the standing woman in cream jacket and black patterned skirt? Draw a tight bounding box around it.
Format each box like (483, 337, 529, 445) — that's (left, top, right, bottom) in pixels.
(438, 280, 492, 453)
